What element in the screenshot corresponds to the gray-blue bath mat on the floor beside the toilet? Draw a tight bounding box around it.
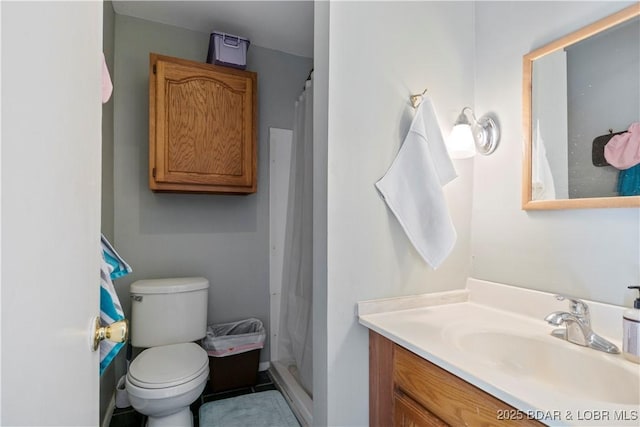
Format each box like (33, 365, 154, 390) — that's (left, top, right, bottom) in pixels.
(198, 390, 300, 427)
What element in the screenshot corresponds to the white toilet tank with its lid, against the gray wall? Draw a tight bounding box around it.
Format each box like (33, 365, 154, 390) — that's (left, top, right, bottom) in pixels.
(130, 277, 209, 347)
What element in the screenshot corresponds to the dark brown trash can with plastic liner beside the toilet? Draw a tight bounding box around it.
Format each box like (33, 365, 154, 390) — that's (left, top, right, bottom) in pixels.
(202, 318, 266, 392)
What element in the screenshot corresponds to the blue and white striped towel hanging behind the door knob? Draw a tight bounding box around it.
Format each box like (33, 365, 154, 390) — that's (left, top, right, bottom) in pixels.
(100, 235, 132, 375)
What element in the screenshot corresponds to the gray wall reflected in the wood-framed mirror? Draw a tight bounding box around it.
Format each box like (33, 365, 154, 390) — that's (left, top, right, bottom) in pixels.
(567, 18, 640, 198)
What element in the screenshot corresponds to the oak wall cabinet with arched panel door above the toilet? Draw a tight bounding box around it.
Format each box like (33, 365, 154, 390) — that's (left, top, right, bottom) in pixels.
(149, 53, 257, 194)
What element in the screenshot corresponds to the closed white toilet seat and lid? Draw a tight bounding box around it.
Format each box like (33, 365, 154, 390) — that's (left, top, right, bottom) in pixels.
(127, 343, 209, 389)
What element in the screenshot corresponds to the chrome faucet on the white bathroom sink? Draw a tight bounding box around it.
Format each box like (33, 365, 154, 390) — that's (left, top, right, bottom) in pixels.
(544, 295, 620, 354)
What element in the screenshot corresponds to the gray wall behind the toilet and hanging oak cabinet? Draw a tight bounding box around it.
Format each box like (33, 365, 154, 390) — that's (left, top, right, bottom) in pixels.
(114, 15, 312, 368)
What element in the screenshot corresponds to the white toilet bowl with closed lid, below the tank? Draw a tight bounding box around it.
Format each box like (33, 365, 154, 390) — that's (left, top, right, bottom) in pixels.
(125, 343, 209, 427)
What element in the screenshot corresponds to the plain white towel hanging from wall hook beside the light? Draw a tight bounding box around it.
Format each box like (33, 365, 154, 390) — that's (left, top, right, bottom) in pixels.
(376, 97, 457, 269)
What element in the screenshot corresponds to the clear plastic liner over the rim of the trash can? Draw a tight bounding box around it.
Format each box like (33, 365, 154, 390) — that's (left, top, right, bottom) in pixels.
(202, 318, 267, 357)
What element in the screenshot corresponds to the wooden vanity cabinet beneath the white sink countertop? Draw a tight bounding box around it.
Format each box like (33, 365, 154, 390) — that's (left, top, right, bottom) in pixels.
(369, 331, 543, 427)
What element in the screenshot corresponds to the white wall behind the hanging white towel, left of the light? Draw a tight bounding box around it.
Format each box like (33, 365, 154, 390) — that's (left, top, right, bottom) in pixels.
(314, 2, 474, 426)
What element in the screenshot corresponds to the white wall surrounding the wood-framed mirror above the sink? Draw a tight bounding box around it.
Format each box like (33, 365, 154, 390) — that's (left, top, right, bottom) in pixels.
(471, 2, 640, 306)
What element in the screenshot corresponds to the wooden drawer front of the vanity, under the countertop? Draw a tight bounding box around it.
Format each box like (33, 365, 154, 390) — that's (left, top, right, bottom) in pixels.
(393, 345, 544, 426)
